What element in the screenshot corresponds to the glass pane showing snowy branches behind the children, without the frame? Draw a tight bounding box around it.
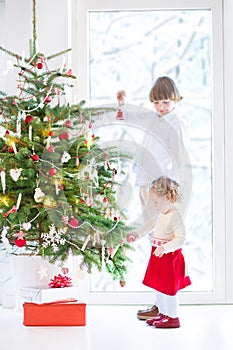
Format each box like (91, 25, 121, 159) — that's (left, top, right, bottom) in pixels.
(89, 10, 213, 292)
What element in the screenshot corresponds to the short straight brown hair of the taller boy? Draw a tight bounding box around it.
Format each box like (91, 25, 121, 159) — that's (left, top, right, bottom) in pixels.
(149, 76, 182, 102)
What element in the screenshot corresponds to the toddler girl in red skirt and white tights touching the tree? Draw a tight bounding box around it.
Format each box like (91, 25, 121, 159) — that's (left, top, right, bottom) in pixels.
(127, 177, 191, 328)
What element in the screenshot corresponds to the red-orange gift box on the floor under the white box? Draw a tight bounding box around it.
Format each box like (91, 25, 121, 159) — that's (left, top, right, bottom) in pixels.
(23, 298, 86, 326)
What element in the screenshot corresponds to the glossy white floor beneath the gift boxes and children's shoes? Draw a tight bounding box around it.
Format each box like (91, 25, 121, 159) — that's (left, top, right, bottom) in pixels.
(0, 305, 233, 350)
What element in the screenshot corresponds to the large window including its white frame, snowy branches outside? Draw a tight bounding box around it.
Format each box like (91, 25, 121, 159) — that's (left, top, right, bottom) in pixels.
(72, 1, 224, 302)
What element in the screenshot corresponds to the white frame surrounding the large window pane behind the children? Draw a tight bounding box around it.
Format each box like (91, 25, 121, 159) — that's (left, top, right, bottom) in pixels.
(69, 0, 233, 304)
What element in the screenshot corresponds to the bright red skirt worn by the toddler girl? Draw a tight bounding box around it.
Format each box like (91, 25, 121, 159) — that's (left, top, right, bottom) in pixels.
(142, 247, 191, 295)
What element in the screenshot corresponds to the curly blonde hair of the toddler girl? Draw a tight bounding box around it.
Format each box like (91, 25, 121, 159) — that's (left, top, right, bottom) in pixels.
(151, 176, 181, 203)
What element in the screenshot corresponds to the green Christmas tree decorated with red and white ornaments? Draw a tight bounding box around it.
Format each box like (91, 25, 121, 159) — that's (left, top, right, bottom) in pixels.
(0, 0, 132, 281)
